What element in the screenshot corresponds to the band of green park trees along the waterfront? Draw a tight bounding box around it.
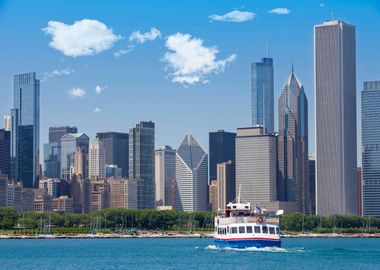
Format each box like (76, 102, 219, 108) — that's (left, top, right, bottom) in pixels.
(0, 208, 380, 234)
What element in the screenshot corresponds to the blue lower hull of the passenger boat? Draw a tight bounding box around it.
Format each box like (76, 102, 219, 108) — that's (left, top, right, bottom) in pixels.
(214, 239, 281, 248)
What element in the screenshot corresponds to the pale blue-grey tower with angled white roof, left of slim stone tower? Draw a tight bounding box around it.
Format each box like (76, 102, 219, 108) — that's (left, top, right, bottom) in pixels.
(61, 133, 89, 180)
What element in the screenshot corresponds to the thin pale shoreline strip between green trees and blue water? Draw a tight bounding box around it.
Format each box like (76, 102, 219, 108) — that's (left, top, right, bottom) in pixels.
(0, 233, 380, 240)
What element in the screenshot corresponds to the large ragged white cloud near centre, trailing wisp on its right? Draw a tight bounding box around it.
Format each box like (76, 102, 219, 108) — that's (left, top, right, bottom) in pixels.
(163, 33, 236, 86)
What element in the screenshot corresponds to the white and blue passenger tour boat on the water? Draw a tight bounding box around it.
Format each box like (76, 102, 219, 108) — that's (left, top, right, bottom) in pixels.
(214, 192, 284, 248)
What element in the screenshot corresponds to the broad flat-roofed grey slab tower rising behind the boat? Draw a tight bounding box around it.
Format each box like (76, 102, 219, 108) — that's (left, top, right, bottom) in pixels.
(236, 128, 277, 205)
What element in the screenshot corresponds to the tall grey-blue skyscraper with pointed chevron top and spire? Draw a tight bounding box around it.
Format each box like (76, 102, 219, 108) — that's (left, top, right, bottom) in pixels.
(277, 68, 311, 215)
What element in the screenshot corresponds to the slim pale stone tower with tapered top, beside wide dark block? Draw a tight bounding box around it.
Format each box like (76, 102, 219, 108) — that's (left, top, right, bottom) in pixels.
(88, 138, 106, 179)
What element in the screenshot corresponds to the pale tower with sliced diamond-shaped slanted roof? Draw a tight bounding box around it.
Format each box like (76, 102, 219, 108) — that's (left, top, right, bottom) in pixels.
(176, 135, 208, 212)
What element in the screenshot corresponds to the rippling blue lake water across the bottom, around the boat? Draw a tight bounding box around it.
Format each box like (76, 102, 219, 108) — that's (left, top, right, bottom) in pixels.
(0, 239, 380, 270)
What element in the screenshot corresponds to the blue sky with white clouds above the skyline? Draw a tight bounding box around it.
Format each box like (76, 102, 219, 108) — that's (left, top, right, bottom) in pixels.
(0, 0, 380, 163)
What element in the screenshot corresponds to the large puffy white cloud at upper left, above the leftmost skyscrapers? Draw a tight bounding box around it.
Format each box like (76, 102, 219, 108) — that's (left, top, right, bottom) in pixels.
(42, 19, 121, 57)
